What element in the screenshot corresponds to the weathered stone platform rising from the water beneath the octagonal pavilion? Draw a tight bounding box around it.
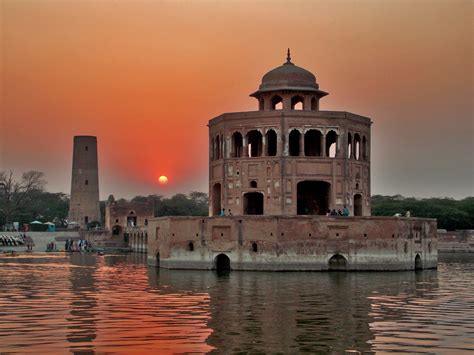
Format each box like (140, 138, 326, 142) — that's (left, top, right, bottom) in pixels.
(147, 216, 438, 271)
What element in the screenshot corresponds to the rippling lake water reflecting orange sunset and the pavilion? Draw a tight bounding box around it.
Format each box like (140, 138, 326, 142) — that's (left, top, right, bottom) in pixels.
(0, 254, 474, 354)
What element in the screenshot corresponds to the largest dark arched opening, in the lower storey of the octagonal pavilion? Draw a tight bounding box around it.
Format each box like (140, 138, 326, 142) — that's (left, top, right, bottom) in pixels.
(296, 181, 331, 215)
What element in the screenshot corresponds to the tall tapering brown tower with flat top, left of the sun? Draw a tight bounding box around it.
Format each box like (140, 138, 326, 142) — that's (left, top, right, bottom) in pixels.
(69, 136, 101, 228)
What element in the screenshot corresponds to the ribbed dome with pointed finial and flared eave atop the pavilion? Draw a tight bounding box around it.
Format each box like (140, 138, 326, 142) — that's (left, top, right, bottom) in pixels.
(250, 50, 327, 97)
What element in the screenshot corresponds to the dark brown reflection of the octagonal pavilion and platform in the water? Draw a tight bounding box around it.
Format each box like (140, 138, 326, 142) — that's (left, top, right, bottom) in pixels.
(149, 269, 437, 353)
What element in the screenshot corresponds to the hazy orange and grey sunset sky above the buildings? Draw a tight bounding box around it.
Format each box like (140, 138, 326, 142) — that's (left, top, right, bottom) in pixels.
(0, 0, 474, 199)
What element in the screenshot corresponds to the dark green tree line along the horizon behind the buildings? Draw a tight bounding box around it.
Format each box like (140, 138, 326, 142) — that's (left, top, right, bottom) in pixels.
(0, 171, 474, 230)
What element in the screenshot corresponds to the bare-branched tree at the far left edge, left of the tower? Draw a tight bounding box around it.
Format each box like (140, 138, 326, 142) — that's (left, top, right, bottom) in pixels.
(0, 170, 46, 225)
